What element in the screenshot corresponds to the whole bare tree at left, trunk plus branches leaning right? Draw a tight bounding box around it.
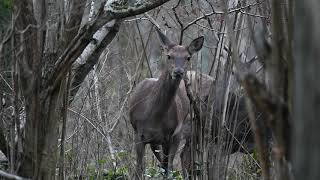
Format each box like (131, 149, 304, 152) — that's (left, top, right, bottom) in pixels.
(0, 0, 172, 179)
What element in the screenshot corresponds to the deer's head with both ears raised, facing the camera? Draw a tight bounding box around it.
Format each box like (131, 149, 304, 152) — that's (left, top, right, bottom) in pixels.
(156, 28, 204, 80)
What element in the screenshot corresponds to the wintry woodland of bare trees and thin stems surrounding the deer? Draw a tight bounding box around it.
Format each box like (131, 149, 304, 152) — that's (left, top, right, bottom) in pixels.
(0, 0, 320, 180)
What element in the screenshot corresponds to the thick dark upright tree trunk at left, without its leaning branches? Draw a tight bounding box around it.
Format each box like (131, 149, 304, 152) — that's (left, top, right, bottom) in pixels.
(15, 0, 81, 179)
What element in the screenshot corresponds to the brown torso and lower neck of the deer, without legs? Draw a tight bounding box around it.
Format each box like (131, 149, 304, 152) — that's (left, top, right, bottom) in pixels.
(130, 72, 189, 144)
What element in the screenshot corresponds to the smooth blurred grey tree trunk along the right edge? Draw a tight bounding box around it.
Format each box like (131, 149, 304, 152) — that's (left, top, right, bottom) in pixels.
(291, 0, 320, 180)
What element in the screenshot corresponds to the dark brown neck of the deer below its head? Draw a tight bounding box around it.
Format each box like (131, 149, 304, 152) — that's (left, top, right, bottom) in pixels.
(152, 70, 181, 118)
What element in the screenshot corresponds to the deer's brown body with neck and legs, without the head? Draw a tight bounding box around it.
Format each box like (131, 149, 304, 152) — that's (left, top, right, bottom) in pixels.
(130, 70, 189, 175)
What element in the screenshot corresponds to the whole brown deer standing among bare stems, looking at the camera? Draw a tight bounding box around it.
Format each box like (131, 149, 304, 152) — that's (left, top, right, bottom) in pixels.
(129, 28, 204, 179)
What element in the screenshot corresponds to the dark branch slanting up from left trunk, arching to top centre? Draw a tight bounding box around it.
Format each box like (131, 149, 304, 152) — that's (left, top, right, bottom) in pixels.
(45, 0, 174, 95)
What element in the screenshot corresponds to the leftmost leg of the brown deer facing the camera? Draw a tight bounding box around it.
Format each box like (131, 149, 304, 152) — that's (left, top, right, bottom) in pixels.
(135, 134, 145, 180)
